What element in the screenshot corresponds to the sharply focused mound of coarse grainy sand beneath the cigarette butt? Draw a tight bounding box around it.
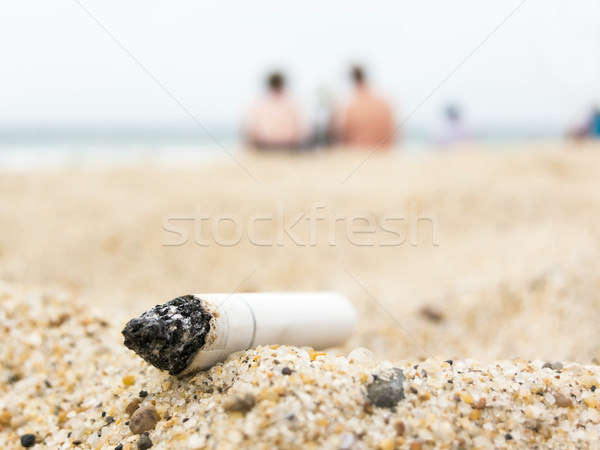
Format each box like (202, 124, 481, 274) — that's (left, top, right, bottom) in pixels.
(0, 286, 600, 449)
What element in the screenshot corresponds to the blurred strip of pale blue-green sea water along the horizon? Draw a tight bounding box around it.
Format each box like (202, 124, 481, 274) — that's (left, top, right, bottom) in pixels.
(0, 129, 560, 172)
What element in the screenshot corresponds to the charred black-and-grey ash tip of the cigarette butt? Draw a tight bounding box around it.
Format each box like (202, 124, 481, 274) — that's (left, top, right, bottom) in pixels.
(122, 295, 212, 375)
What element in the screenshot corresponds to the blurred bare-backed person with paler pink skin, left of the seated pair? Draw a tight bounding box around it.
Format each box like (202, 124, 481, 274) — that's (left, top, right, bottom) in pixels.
(247, 72, 302, 150)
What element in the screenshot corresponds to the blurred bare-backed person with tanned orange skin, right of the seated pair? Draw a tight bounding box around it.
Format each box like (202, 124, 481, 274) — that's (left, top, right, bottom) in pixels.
(339, 66, 396, 149)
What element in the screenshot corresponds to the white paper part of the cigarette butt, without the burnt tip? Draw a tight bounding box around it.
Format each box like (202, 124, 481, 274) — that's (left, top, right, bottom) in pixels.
(185, 292, 356, 372)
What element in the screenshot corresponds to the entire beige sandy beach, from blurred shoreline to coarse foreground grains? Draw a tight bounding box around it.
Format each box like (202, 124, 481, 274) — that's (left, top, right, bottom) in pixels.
(0, 143, 600, 448)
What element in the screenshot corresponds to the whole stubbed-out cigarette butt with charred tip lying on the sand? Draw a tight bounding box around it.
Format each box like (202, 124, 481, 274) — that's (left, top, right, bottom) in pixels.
(123, 292, 356, 375)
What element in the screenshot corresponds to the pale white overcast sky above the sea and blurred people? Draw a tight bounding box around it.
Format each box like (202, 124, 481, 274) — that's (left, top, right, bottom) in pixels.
(0, 0, 600, 134)
